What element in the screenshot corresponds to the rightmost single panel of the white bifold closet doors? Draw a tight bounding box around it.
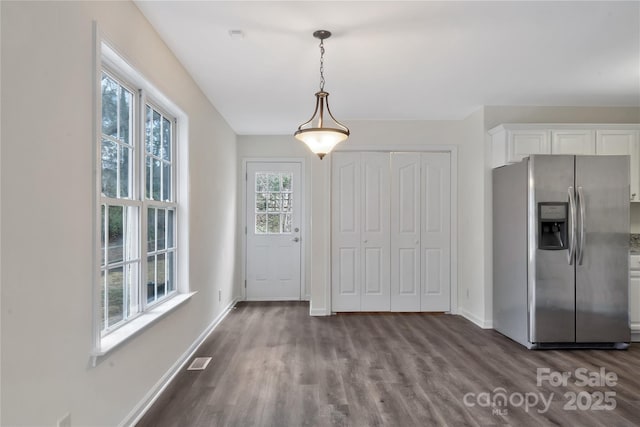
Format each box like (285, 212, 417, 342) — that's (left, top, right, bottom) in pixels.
(420, 153, 451, 311)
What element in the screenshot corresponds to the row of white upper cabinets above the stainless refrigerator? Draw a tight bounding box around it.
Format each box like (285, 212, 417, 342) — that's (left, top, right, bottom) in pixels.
(489, 123, 640, 202)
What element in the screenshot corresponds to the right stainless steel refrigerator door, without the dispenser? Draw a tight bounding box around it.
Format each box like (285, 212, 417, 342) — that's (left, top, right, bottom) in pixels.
(576, 156, 631, 343)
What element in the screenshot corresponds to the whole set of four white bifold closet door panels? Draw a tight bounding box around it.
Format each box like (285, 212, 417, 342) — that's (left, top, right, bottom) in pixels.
(332, 152, 451, 312)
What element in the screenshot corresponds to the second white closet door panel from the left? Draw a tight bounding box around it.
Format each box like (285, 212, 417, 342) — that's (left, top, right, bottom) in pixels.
(356, 153, 390, 311)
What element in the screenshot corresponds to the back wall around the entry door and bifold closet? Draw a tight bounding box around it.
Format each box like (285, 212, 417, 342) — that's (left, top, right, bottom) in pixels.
(237, 110, 485, 321)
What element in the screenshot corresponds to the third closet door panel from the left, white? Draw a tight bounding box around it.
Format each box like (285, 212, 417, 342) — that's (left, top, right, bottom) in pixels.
(391, 153, 421, 311)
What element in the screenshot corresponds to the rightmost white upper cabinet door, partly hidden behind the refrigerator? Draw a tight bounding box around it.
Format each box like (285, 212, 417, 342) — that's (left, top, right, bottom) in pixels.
(596, 130, 640, 202)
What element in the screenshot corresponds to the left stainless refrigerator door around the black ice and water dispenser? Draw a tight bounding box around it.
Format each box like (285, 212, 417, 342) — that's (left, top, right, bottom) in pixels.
(528, 155, 575, 343)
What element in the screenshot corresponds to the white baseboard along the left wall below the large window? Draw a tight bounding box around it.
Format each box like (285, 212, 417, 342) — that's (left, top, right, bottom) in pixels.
(118, 297, 239, 427)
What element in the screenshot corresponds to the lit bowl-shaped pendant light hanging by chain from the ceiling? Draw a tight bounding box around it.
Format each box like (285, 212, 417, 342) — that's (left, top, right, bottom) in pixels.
(293, 30, 349, 160)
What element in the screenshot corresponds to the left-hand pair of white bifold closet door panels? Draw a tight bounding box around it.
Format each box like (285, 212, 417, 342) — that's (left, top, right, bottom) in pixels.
(332, 152, 390, 311)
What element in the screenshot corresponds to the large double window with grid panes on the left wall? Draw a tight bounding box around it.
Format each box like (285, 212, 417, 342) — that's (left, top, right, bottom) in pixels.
(99, 69, 177, 336)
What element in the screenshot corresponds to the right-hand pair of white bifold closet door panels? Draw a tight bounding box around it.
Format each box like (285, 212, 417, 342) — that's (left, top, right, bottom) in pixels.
(391, 153, 451, 311)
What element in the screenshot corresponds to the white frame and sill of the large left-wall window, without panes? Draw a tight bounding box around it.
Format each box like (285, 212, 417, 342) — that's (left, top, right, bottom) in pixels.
(90, 39, 195, 366)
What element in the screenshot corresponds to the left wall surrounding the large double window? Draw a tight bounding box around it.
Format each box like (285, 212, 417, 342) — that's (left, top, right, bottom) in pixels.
(0, 1, 237, 426)
